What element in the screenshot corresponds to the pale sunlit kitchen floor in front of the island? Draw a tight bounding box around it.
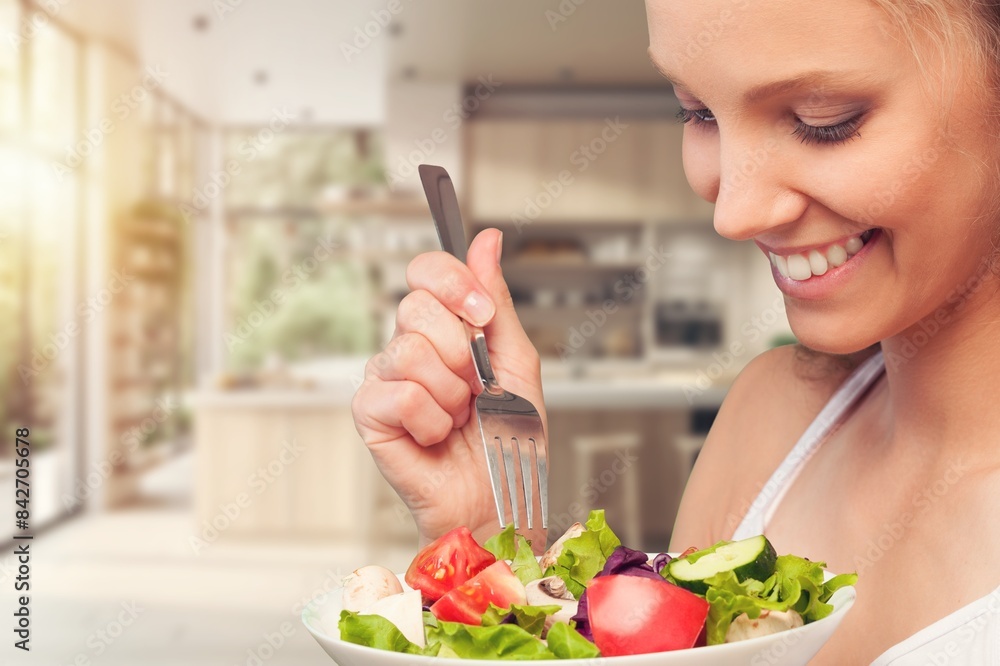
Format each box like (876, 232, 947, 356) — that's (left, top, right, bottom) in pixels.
(0, 452, 414, 666)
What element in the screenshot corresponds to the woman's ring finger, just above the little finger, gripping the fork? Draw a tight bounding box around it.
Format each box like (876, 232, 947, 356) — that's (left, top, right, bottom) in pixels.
(365, 333, 472, 427)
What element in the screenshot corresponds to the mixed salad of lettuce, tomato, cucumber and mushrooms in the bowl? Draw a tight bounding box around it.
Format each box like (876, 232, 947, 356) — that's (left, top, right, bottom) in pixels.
(338, 511, 857, 660)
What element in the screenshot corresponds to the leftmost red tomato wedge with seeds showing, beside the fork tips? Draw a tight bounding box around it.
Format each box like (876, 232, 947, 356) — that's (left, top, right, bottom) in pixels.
(404, 527, 497, 601)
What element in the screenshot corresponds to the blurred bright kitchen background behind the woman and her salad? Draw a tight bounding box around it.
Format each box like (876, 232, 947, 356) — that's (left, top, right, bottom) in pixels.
(0, 0, 791, 664)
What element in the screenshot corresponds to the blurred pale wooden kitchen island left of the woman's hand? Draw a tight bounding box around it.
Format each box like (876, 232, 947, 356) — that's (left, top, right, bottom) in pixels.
(194, 391, 384, 540)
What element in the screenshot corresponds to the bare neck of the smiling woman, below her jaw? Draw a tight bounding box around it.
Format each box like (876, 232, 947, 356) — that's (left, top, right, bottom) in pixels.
(882, 273, 1000, 455)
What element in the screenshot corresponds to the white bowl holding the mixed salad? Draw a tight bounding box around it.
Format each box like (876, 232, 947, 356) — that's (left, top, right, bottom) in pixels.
(302, 573, 855, 666)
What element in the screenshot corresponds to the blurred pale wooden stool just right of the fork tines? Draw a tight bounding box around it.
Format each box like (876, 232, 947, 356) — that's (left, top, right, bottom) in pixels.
(573, 432, 642, 548)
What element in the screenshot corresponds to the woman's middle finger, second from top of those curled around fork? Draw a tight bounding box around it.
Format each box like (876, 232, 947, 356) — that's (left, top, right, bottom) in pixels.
(393, 289, 478, 387)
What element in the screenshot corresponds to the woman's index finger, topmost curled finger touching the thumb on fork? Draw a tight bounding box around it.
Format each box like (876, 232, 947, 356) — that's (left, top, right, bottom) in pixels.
(406, 252, 496, 326)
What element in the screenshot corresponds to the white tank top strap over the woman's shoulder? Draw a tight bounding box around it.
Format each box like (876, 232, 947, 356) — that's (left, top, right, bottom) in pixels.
(732, 351, 885, 540)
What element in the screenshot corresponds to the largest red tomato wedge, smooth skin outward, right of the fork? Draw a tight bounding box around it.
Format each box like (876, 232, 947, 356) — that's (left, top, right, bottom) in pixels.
(587, 575, 708, 657)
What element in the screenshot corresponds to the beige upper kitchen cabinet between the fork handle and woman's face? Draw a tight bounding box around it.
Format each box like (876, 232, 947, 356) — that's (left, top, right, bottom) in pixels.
(467, 118, 712, 222)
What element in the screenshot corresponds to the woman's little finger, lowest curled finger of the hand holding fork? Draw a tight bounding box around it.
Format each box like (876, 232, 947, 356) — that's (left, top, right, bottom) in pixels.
(352, 379, 454, 446)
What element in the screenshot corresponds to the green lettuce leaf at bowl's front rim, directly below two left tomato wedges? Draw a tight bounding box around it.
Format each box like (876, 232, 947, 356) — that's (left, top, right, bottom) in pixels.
(427, 622, 556, 661)
